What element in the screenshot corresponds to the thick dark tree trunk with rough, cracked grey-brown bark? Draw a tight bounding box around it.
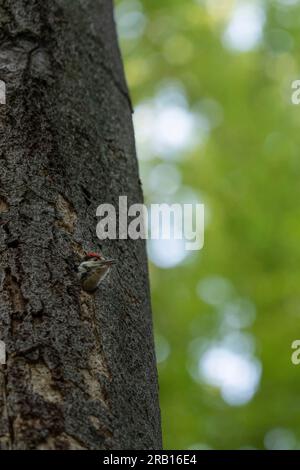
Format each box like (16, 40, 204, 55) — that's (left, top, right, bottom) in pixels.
(0, 0, 161, 449)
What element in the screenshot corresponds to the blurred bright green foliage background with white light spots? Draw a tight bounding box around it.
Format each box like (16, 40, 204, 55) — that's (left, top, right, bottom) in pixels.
(115, 0, 300, 449)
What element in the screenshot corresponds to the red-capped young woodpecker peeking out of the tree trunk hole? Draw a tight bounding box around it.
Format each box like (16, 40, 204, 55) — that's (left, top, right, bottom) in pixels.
(78, 253, 116, 292)
